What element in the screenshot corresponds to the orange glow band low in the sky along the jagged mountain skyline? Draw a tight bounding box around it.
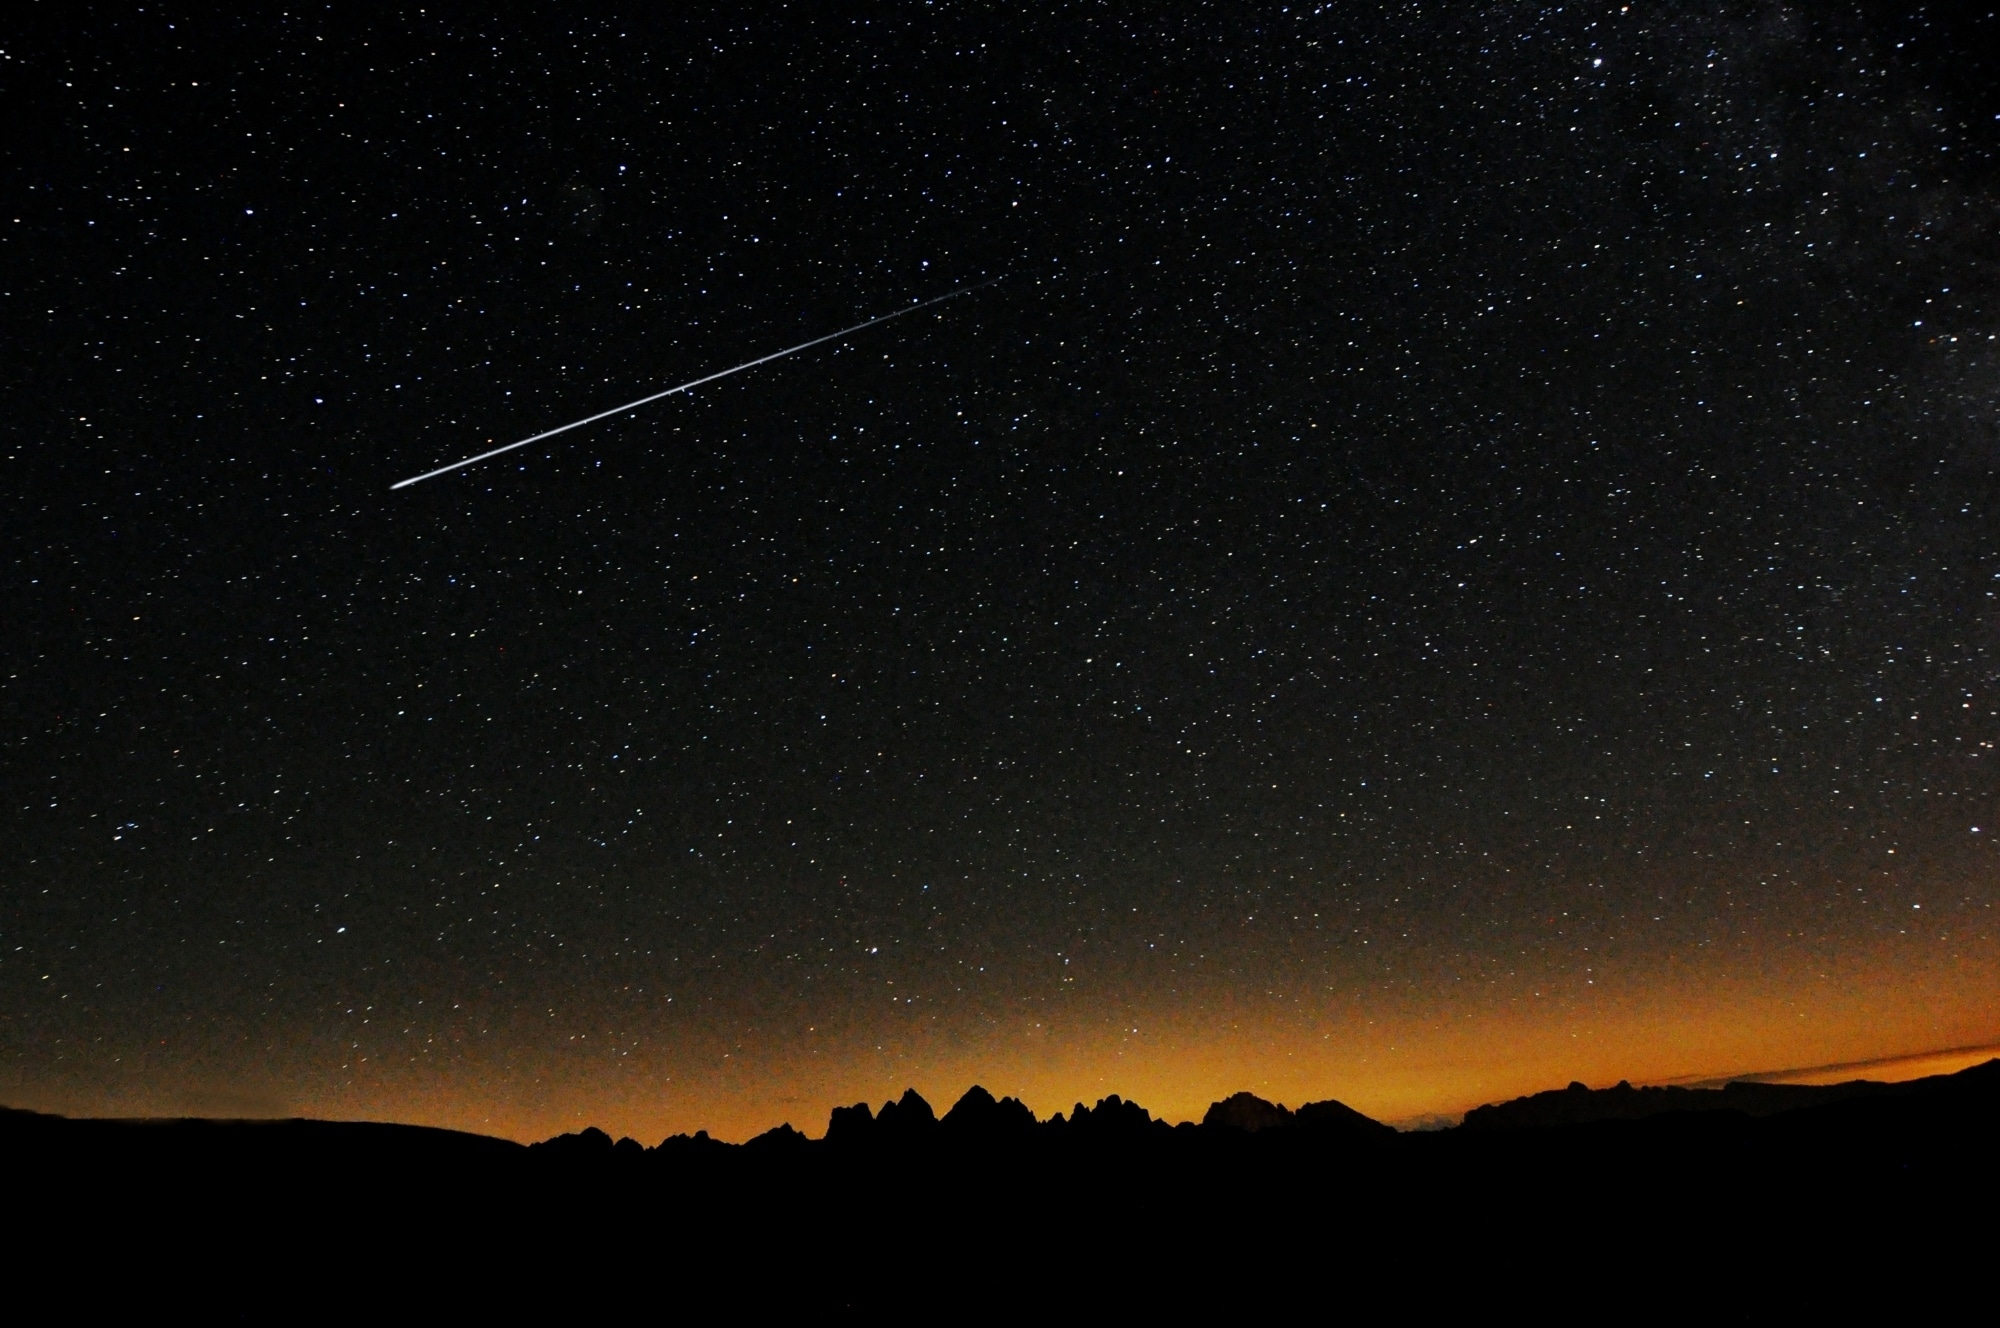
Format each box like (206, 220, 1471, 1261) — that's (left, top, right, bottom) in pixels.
(0, 928, 2000, 1144)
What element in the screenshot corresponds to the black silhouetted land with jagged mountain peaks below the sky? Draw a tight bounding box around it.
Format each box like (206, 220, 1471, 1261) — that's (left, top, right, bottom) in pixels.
(0, 1062, 2000, 1322)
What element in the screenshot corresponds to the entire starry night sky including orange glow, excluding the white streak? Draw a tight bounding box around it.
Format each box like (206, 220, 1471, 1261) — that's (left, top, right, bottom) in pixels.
(0, 2, 2000, 1142)
